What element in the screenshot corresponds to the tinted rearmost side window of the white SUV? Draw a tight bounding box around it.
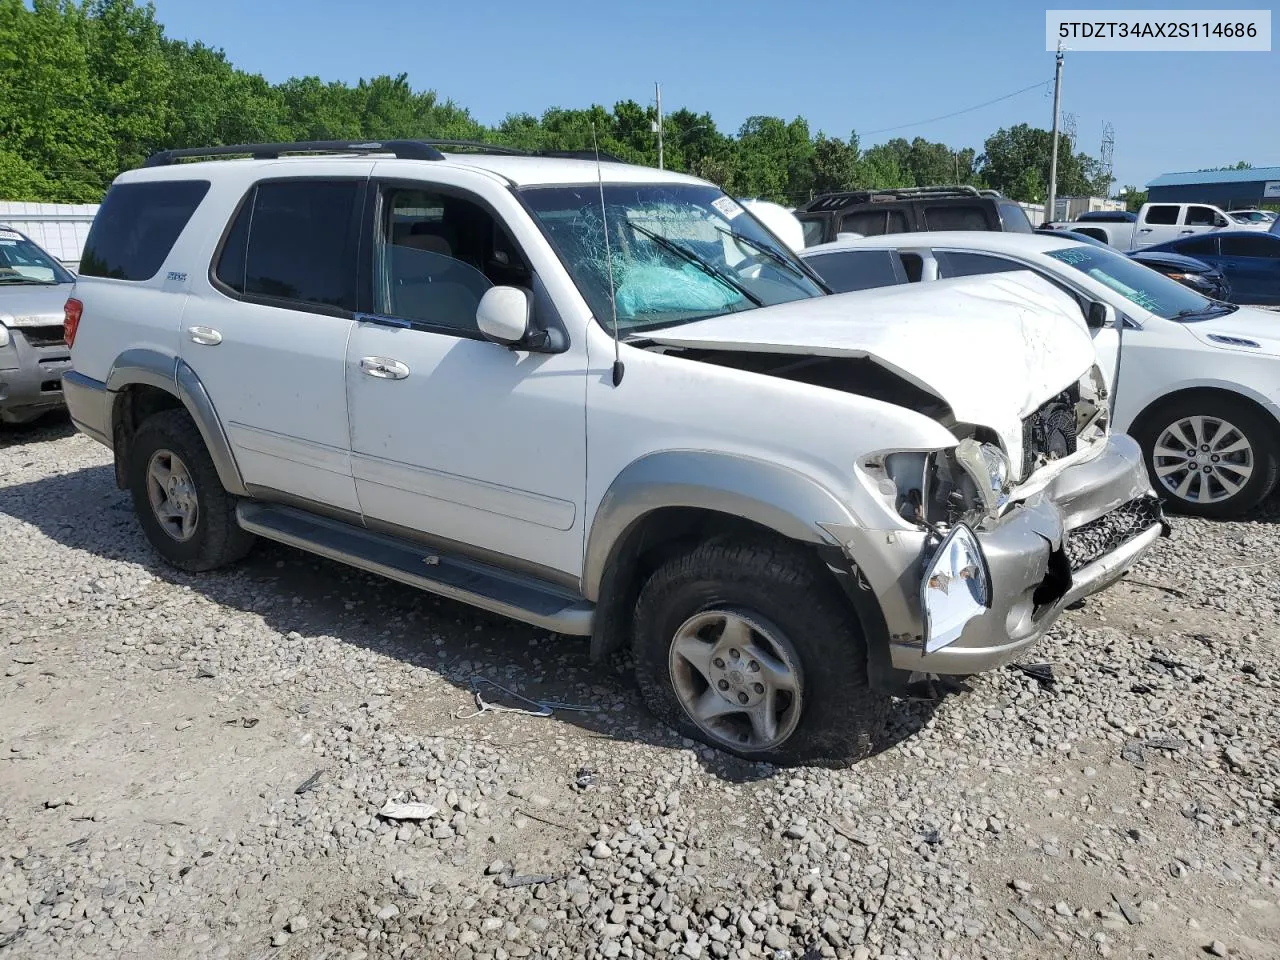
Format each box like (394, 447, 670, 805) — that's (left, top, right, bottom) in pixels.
(79, 180, 209, 282)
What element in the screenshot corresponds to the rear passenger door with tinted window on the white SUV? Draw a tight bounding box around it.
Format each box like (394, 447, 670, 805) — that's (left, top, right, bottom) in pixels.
(182, 175, 371, 513)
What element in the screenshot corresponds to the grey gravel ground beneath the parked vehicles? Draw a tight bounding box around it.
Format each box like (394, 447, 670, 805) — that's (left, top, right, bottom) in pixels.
(0, 422, 1280, 960)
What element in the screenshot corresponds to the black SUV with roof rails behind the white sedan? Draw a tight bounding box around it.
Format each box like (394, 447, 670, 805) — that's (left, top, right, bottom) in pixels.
(796, 187, 1032, 247)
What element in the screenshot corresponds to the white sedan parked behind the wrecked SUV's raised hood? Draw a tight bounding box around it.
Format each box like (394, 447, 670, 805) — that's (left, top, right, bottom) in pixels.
(801, 230, 1280, 517)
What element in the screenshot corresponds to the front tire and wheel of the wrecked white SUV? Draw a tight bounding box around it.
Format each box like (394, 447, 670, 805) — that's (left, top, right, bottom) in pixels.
(632, 540, 888, 765)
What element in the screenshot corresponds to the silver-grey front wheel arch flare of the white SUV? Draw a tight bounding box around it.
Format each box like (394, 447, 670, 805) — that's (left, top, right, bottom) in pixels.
(582, 451, 856, 602)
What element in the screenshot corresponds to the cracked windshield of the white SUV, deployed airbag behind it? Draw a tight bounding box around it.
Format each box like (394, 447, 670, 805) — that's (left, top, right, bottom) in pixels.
(522, 183, 823, 335)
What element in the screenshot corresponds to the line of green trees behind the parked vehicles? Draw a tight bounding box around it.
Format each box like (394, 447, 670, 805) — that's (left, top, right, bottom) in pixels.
(0, 0, 1111, 204)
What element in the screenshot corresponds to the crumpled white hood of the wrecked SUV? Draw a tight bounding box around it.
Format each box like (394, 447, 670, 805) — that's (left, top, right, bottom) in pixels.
(645, 271, 1096, 463)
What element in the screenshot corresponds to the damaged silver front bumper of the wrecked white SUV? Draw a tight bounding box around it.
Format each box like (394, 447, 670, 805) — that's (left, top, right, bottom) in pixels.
(826, 435, 1169, 675)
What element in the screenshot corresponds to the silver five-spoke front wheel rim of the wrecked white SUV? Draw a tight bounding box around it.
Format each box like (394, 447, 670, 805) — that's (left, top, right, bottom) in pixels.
(669, 611, 804, 750)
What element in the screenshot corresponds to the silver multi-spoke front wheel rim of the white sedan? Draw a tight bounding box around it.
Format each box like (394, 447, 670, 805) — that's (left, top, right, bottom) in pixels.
(1151, 416, 1254, 503)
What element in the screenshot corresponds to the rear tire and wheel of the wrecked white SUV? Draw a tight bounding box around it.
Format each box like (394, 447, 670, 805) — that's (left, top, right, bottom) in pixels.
(128, 410, 255, 573)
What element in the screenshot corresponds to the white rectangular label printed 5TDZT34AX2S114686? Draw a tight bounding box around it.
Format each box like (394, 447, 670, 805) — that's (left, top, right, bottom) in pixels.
(1044, 10, 1271, 52)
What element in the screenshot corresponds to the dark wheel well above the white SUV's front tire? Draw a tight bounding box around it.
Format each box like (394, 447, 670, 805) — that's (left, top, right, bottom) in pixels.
(591, 507, 839, 659)
